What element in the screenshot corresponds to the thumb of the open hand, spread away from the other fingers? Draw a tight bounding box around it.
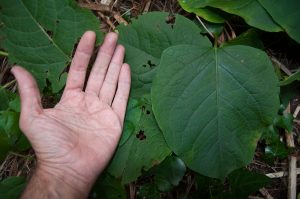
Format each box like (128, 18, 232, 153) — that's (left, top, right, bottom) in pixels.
(11, 66, 43, 119)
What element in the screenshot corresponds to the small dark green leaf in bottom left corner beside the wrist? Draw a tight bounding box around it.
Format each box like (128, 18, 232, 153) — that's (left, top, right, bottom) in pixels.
(0, 177, 26, 199)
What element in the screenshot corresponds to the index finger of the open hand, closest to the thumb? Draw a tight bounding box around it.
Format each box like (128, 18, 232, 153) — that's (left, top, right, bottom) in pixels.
(64, 31, 96, 92)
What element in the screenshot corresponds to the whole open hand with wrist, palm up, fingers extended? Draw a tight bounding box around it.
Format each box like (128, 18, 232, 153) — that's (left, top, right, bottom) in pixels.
(11, 31, 130, 199)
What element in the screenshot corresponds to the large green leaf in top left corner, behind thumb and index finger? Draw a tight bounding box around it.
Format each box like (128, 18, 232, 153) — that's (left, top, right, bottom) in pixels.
(0, 0, 101, 91)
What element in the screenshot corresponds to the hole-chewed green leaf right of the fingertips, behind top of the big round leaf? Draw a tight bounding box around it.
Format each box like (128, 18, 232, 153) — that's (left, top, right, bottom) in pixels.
(118, 12, 211, 97)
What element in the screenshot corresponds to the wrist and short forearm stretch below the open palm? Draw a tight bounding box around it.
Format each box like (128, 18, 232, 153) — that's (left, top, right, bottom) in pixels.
(21, 167, 93, 199)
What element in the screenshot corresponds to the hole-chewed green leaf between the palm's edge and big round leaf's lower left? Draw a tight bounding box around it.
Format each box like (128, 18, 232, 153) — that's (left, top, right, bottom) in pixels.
(108, 96, 171, 184)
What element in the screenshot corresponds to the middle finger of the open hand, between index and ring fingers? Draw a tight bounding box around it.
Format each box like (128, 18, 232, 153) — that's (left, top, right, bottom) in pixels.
(85, 32, 118, 95)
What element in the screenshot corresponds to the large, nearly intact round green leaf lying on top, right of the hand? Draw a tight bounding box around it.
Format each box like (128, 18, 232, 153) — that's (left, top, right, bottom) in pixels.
(152, 45, 279, 178)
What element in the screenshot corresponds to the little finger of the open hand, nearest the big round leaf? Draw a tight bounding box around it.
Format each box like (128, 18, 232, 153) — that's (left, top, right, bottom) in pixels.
(112, 64, 131, 121)
